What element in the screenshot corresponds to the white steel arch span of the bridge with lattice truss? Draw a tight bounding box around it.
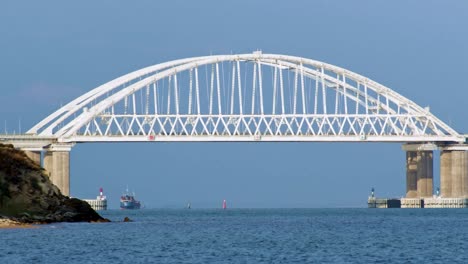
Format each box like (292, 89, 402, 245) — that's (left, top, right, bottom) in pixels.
(28, 52, 465, 142)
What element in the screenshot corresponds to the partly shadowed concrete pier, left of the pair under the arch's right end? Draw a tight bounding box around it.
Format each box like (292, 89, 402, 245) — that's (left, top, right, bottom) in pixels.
(403, 144, 436, 198)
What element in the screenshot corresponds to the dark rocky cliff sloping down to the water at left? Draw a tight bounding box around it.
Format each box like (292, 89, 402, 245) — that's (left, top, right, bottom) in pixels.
(0, 144, 109, 223)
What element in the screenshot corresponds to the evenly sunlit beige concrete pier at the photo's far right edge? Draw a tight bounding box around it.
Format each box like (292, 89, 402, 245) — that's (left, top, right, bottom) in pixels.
(440, 146, 468, 198)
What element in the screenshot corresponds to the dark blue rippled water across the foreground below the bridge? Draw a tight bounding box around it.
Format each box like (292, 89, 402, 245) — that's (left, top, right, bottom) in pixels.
(0, 209, 468, 264)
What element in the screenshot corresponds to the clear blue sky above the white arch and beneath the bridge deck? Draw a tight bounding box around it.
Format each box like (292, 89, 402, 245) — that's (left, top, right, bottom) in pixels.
(0, 0, 468, 208)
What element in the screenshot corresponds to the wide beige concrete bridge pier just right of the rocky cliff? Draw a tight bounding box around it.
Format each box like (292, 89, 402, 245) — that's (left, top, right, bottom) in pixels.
(44, 144, 72, 196)
